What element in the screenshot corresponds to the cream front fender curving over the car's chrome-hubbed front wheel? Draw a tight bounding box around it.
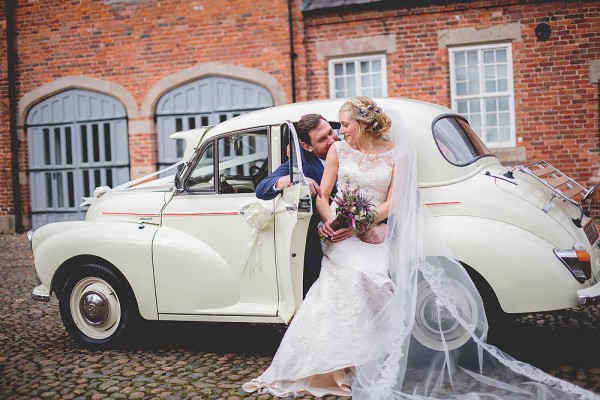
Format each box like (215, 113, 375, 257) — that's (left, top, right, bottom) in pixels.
(32, 221, 158, 319)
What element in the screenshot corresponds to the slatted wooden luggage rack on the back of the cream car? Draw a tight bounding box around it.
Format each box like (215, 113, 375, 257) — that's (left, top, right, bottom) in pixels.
(511, 161, 595, 206)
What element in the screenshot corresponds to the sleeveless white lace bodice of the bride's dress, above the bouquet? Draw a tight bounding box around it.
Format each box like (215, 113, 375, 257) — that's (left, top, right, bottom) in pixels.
(335, 142, 394, 206)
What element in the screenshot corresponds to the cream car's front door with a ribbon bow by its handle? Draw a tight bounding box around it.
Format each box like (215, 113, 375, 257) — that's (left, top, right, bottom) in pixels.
(152, 127, 280, 321)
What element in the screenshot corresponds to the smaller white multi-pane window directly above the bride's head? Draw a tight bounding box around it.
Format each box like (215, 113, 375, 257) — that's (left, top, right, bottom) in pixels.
(329, 55, 387, 98)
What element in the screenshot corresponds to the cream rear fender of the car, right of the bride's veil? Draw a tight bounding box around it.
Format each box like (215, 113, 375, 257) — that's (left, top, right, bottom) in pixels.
(425, 216, 589, 313)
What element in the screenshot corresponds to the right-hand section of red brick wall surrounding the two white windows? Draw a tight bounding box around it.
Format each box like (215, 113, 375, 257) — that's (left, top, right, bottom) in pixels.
(305, 1, 600, 212)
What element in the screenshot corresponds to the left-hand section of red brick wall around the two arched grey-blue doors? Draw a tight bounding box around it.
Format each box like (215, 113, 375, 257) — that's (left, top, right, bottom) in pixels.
(0, 0, 301, 228)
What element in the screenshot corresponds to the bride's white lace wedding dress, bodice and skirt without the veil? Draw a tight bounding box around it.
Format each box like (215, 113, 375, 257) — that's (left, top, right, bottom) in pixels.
(243, 142, 394, 396)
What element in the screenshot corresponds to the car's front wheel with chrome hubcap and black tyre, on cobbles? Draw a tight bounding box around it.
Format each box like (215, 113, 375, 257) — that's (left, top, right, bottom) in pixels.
(59, 264, 135, 347)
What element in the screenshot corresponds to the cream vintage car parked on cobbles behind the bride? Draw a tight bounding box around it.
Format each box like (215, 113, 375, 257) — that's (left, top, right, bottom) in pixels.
(32, 99, 600, 349)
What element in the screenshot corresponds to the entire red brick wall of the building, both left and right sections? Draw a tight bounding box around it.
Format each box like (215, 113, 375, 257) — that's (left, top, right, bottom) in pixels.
(0, 0, 600, 228)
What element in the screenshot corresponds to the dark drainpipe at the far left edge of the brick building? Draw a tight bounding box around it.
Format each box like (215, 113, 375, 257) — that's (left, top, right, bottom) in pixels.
(4, 0, 24, 233)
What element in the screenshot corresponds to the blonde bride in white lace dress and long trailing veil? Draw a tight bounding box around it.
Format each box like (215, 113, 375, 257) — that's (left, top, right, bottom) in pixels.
(243, 96, 600, 399)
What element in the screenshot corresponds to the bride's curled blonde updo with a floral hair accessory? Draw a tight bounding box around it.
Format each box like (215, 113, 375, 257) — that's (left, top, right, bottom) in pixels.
(340, 96, 392, 146)
